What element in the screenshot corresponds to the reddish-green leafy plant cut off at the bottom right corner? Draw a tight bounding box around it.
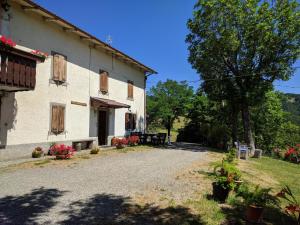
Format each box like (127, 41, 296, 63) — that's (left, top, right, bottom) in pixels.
(276, 186, 300, 225)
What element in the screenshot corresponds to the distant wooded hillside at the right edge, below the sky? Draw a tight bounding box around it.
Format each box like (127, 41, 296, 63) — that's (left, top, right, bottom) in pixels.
(282, 94, 300, 125)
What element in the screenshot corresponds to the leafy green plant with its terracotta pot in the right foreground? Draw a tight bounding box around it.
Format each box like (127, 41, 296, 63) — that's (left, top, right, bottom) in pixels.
(237, 185, 278, 223)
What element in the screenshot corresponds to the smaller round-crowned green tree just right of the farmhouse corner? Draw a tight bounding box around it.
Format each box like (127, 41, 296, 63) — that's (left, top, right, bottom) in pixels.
(147, 80, 193, 142)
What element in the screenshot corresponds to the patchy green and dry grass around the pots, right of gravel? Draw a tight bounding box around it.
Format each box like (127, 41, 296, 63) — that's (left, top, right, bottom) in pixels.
(155, 151, 300, 225)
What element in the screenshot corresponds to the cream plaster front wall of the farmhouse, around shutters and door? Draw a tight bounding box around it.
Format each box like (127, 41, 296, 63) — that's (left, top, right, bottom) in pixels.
(0, 2, 144, 145)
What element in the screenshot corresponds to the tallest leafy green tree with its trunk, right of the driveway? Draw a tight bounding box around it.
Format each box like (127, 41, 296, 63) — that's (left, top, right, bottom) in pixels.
(186, 0, 300, 152)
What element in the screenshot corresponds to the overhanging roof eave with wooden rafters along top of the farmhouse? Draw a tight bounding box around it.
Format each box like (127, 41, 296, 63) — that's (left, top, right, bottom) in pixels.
(14, 0, 157, 74)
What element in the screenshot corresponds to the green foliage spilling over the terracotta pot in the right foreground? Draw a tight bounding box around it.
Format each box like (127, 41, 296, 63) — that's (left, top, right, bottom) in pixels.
(237, 185, 278, 207)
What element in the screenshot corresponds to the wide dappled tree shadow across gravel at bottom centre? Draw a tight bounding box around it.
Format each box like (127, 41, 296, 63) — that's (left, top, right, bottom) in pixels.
(60, 194, 205, 225)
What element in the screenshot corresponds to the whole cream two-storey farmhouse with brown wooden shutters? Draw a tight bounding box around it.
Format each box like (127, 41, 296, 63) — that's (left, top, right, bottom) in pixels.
(0, 0, 156, 160)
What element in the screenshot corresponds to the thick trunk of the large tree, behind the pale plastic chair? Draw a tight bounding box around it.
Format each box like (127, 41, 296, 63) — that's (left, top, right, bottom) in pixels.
(242, 104, 255, 155)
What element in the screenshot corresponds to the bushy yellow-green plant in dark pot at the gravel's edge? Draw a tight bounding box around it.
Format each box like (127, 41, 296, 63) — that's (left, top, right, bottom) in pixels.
(212, 160, 241, 202)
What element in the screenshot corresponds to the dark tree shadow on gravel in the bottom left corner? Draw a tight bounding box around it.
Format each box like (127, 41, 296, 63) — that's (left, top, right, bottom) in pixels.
(0, 187, 64, 225)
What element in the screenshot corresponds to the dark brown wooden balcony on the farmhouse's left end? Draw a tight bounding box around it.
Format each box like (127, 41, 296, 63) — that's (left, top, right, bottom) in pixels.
(0, 46, 44, 92)
